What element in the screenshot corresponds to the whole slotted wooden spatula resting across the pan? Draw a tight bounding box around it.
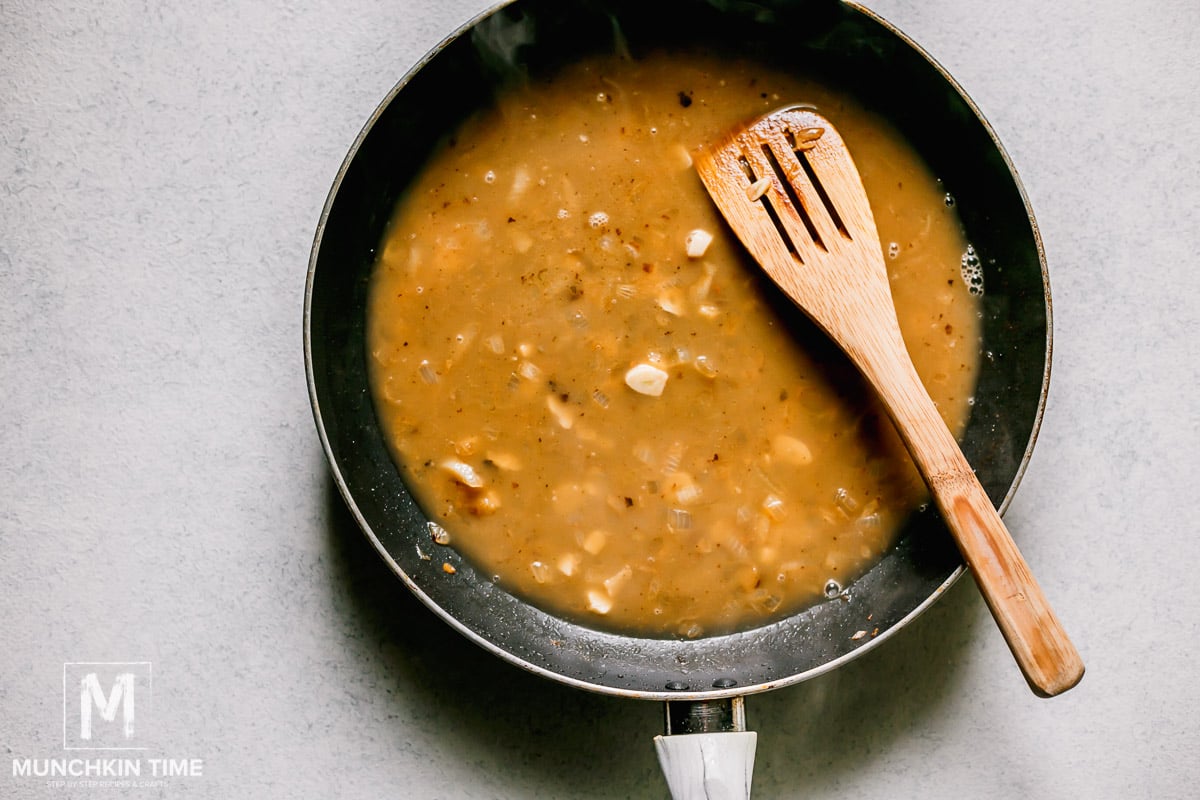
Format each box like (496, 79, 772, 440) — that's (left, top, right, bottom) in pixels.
(695, 106, 1084, 697)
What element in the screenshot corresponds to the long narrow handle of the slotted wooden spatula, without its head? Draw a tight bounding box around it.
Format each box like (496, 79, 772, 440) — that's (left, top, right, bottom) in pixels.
(869, 335, 1084, 697)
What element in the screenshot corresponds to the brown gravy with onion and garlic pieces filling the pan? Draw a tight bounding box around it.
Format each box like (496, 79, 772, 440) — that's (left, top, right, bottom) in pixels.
(367, 55, 982, 637)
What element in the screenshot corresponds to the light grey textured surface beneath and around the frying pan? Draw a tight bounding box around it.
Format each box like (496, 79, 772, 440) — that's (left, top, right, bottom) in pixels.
(0, 0, 1200, 799)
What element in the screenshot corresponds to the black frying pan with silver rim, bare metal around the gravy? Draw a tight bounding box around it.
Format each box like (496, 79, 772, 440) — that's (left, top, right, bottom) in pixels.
(304, 0, 1050, 791)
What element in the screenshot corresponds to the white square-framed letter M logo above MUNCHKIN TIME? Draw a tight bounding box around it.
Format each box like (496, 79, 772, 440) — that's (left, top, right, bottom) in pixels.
(62, 661, 154, 750)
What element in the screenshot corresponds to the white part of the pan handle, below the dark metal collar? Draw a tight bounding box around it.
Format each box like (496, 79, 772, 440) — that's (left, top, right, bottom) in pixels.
(654, 730, 758, 800)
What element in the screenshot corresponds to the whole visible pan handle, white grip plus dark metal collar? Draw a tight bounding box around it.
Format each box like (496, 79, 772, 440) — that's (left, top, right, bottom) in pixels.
(654, 697, 758, 800)
